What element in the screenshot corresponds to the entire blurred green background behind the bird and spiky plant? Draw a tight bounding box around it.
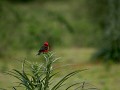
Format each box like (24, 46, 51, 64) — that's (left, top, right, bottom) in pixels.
(0, 0, 120, 90)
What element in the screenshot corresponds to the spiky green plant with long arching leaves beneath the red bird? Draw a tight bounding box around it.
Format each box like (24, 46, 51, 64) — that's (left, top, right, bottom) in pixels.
(4, 53, 97, 90)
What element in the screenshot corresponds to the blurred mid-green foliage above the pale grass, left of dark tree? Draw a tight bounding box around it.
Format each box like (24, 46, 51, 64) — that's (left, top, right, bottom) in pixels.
(0, 0, 105, 57)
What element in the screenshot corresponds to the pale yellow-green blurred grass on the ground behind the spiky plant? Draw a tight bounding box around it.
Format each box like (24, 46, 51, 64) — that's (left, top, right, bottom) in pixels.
(0, 48, 120, 90)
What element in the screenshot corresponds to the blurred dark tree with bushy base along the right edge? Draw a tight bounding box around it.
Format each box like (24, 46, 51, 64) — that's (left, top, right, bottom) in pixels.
(92, 0, 120, 63)
